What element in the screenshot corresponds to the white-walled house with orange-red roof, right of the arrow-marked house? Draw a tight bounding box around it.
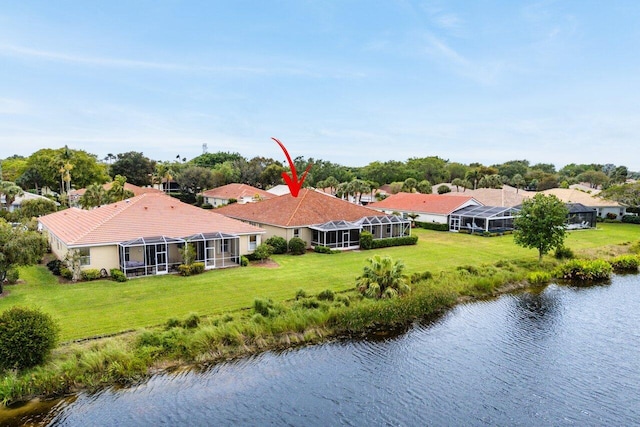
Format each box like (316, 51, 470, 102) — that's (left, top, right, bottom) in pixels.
(367, 193, 481, 224)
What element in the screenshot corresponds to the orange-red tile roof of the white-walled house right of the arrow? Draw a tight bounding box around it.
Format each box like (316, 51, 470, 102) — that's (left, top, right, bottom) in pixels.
(367, 193, 474, 215)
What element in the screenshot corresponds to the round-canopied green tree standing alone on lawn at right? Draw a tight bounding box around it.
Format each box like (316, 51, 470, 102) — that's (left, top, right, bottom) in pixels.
(514, 193, 569, 261)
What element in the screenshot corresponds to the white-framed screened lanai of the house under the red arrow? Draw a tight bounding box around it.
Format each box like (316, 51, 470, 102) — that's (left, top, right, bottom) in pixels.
(309, 215, 411, 249)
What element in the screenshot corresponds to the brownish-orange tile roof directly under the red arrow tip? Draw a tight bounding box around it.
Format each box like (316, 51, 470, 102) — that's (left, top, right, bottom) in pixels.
(216, 188, 384, 227)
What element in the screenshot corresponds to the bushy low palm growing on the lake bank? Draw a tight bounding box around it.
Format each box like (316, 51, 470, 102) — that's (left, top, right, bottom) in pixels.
(356, 255, 411, 298)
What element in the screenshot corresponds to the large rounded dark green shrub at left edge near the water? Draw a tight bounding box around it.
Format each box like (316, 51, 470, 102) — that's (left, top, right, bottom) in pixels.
(0, 307, 58, 370)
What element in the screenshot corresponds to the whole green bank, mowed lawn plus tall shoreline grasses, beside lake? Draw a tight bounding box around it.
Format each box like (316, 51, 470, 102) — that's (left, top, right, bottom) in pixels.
(0, 224, 640, 403)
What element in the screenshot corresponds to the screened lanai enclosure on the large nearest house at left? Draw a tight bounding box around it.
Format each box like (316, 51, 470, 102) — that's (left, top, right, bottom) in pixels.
(118, 232, 240, 277)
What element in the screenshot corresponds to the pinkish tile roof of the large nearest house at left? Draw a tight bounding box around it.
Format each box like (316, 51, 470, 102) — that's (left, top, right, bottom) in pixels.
(39, 193, 264, 246)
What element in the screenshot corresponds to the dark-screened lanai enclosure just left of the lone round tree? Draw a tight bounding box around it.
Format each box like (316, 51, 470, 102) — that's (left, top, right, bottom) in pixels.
(449, 206, 520, 233)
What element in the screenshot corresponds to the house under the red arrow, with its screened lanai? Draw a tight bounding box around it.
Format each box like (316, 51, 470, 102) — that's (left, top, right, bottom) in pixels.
(216, 188, 411, 249)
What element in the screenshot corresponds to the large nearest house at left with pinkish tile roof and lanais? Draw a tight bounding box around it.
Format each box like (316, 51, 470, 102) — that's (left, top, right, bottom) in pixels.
(38, 193, 264, 276)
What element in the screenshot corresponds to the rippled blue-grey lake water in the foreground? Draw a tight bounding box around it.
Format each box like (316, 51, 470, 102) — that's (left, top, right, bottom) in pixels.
(5, 275, 640, 426)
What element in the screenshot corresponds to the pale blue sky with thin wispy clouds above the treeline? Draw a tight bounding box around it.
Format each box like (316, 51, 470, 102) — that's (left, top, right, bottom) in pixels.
(0, 0, 640, 171)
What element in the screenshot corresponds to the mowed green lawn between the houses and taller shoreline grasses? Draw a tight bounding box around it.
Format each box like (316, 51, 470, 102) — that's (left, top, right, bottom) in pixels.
(0, 224, 640, 341)
